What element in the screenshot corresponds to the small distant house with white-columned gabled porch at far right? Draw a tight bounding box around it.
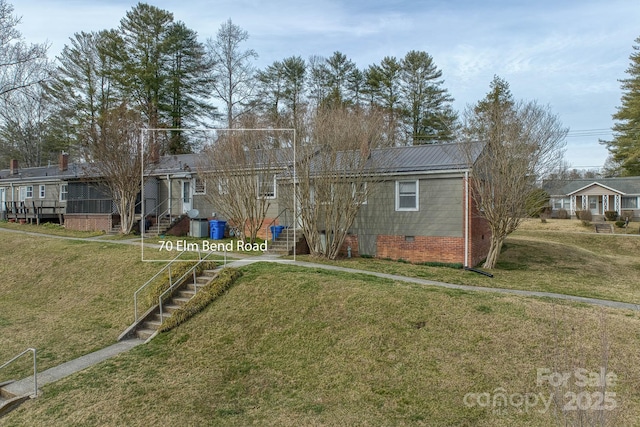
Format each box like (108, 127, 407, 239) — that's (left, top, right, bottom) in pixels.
(543, 177, 640, 221)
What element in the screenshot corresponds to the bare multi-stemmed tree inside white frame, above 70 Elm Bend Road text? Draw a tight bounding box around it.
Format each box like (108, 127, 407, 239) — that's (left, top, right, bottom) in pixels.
(197, 122, 279, 243)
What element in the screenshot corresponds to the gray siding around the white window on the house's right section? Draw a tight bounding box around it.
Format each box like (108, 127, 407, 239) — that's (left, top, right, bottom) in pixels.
(351, 176, 463, 239)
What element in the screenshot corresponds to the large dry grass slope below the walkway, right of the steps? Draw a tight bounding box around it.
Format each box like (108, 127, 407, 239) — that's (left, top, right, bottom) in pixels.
(6, 264, 640, 426)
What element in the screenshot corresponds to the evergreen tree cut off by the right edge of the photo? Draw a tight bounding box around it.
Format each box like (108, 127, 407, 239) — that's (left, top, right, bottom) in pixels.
(605, 37, 640, 176)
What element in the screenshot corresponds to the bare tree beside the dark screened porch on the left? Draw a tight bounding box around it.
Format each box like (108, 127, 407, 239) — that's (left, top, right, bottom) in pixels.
(89, 104, 152, 234)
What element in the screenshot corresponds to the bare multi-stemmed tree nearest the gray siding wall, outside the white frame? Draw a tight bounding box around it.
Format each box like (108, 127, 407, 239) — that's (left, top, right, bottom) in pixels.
(295, 107, 388, 259)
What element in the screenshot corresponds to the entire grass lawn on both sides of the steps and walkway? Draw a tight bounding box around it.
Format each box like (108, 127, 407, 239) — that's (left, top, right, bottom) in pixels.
(0, 222, 640, 426)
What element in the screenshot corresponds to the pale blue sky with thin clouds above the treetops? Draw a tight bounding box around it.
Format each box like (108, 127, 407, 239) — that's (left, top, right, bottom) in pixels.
(7, 0, 640, 169)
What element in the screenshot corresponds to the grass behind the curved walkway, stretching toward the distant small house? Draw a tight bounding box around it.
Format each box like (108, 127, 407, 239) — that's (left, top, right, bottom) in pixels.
(297, 220, 640, 304)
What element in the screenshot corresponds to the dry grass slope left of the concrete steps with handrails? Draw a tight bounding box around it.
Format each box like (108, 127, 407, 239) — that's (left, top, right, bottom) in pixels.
(0, 232, 160, 379)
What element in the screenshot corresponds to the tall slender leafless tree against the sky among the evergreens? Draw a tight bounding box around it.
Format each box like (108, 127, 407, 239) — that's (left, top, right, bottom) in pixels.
(206, 19, 258, 128)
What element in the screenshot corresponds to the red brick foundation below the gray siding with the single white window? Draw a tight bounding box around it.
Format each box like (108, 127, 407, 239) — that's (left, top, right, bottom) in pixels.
(376, 235, 464, 264)
